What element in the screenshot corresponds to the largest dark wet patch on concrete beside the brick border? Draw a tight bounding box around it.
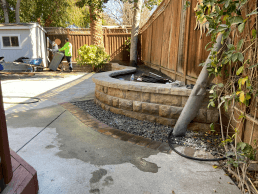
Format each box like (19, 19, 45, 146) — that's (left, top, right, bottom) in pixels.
(53, 111, 159, 173)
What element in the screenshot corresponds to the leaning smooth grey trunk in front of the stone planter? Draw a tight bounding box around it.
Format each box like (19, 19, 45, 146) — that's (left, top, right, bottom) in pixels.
(173, 34, 222, 137)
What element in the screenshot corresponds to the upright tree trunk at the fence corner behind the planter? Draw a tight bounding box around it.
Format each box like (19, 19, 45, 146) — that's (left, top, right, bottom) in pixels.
(130, 0, 143, 67)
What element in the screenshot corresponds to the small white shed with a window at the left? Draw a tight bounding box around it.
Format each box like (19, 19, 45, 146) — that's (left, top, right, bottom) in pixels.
(0, 23, 47, 67)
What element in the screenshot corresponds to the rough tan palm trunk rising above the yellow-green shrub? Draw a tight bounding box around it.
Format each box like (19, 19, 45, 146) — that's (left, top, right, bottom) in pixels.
(90, 7, 104, 48)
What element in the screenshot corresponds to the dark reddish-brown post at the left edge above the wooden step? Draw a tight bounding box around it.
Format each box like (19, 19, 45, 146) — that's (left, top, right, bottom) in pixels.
(0, 81, 13, 184)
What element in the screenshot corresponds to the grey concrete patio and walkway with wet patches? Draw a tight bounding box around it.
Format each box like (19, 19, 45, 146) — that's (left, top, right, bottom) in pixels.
(2, 74, 241, 194)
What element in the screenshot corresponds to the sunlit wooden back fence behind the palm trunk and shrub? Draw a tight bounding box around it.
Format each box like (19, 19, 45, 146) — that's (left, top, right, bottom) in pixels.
(45, 28, 131, 62)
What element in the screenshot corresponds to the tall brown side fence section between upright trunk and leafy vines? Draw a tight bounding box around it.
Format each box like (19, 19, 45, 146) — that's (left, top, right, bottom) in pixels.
(140, 0, 210, 83)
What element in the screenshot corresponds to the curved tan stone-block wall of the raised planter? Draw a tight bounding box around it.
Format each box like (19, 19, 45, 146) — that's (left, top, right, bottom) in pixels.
(92, 63, 219, 131)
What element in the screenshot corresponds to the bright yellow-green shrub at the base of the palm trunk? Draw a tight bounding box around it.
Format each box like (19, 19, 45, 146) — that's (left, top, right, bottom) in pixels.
(76, 45, 110, 71)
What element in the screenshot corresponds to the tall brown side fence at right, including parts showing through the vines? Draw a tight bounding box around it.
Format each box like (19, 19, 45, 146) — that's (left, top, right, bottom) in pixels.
(140, 0, 258, 150)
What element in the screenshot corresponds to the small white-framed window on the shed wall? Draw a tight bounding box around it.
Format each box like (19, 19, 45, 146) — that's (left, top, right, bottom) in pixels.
(0, 34, 20, 49)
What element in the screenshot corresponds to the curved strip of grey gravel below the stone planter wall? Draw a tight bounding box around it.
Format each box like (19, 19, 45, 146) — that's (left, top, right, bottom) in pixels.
(72, 100, 224, 155)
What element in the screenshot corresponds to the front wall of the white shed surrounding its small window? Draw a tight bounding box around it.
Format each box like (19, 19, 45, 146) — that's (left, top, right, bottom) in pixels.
(0, 29, 33, 62)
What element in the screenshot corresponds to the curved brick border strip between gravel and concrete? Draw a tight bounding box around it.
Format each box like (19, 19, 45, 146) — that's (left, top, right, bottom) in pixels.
(60, 102, 172, 154)
